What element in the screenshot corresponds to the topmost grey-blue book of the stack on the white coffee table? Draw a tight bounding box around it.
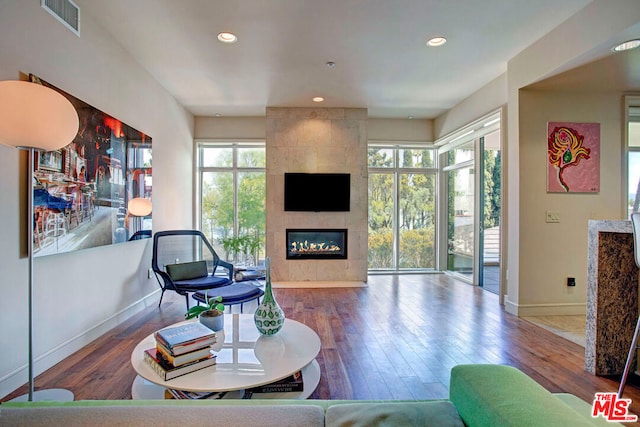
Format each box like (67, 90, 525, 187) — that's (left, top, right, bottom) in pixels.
(154, 322, 216, 356)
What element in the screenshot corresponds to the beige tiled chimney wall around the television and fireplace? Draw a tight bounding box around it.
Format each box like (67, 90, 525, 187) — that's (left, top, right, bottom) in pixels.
(266, 107, 368, 282)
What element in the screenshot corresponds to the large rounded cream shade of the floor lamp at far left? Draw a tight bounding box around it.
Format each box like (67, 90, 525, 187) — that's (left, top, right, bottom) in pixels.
(0, 80, 79, 151)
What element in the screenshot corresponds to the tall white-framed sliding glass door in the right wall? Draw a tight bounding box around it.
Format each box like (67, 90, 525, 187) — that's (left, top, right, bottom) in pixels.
(436, 113, 501, 293)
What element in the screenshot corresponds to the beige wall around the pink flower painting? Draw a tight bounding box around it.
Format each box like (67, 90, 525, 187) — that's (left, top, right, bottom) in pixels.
(518, 90, 624, 315)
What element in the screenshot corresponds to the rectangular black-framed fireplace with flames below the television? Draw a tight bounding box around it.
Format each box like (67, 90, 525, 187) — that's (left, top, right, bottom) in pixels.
(287, 228, 347, 259)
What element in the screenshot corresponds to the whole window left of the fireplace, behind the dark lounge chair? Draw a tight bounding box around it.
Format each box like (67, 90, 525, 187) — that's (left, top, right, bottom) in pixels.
(198, 142, 266, 265)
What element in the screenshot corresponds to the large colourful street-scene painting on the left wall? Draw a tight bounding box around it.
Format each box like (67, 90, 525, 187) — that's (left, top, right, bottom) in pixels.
(29, 75, 152, 256)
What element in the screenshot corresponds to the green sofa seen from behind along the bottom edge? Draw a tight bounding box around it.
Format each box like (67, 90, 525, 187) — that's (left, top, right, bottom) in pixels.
(0, 365, 620, 427)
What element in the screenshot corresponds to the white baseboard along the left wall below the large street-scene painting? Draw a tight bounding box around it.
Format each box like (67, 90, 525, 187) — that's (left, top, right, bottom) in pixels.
(0, 289, 160, 396)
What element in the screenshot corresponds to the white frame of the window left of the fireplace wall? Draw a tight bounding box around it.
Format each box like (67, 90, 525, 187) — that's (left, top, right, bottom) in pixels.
(194, 140, 266, 265)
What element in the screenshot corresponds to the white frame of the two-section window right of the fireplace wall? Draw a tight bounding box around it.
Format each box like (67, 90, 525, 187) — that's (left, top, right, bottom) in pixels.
(367, 140, 438, 273)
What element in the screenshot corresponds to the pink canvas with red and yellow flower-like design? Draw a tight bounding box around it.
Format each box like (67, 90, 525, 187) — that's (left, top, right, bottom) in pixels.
(547, 122, 600, 193)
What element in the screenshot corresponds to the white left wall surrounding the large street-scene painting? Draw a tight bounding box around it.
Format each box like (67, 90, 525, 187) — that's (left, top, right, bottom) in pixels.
(0, 0, 193, 396)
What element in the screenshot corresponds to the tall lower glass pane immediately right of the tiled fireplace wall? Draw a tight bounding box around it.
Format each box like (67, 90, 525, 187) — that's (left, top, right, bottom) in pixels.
(369, 174, 394, 269)
